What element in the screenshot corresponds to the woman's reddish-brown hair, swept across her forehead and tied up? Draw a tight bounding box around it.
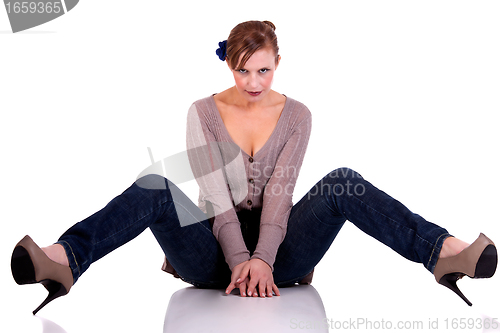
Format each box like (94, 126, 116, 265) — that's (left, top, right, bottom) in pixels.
(226, 21, 279, 70)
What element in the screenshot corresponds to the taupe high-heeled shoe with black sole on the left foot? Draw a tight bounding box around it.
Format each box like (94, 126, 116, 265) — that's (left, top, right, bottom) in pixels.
(10, 236, 73, 315)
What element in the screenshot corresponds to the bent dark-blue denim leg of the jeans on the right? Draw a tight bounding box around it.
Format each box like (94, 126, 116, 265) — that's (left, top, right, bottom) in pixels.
(274, 168, 450, 285)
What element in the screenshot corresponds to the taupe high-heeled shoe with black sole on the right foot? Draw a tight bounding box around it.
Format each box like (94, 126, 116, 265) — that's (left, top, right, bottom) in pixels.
(434, 233, 498, 306)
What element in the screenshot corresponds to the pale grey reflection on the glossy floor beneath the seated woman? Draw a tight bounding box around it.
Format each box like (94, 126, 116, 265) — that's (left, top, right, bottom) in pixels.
(163, 285, 328, 333)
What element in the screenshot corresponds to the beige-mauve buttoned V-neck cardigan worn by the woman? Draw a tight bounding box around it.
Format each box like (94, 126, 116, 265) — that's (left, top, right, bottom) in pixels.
(163, 95, 312, 282)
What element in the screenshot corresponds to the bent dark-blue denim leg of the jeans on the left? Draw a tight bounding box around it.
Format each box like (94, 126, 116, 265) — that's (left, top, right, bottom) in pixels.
(57, 175, 231, 287)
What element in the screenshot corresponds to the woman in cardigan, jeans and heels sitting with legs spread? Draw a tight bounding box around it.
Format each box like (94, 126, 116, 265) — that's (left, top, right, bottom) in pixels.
(11, 21, 497, 313)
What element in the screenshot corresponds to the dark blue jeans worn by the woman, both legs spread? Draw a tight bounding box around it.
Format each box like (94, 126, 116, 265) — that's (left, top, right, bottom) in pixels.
(58, 168, 450, 288)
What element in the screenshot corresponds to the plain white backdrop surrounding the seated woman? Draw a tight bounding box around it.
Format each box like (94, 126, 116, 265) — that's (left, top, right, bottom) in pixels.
(0, 0, 500, 333)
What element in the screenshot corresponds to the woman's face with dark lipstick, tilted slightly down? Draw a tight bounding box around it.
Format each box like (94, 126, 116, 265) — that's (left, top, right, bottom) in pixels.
(232, 49, 279, 102)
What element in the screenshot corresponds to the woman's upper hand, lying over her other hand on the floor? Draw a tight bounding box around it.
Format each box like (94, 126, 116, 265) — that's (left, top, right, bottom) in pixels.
(237, 259, 280, 297)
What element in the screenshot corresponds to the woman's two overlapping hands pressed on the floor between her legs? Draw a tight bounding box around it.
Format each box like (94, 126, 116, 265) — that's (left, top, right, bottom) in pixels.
(226, 259, 280, 297)
